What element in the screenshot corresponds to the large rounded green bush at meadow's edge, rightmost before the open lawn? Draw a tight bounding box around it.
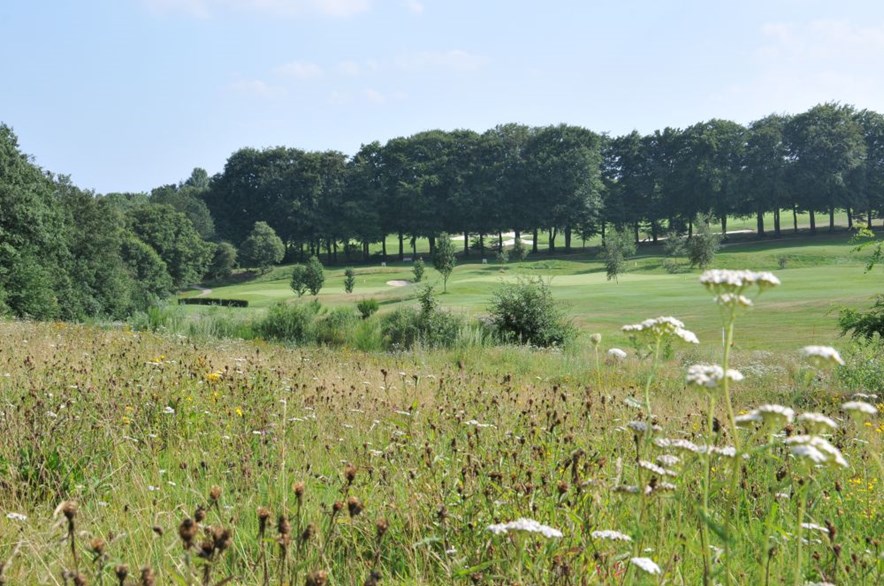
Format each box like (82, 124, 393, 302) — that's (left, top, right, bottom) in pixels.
(490, 278, 576, 347)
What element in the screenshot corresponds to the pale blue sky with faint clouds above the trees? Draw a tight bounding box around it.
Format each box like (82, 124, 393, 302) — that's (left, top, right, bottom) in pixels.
(0, 0, 884, 193)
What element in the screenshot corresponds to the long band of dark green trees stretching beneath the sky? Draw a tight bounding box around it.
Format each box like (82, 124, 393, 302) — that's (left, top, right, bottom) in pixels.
(0, 103, 884, 319)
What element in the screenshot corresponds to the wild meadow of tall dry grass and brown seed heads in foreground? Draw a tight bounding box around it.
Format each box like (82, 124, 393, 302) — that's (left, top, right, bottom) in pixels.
(0, 269, 884, 584)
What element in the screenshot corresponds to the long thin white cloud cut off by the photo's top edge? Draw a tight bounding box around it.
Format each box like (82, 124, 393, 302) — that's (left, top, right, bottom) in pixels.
(142, 0, 372, 18)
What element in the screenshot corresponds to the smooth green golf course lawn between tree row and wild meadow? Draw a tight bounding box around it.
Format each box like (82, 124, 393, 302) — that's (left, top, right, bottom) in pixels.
(186, 232, 882, 349)
